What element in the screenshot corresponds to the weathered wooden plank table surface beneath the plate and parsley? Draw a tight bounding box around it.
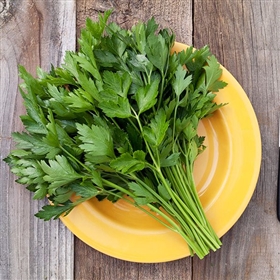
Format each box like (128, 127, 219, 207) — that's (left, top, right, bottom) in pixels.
(0, 0, 280, 280)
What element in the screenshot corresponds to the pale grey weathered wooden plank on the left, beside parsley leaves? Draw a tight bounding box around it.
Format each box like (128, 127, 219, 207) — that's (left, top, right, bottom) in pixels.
(0, 0, 76, 280)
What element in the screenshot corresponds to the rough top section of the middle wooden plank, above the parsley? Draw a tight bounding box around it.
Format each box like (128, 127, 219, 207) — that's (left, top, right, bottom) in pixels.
(77, 0, 192, 44)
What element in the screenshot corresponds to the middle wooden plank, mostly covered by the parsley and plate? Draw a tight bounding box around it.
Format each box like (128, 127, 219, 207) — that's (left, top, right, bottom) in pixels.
(75, 0, 192, 280)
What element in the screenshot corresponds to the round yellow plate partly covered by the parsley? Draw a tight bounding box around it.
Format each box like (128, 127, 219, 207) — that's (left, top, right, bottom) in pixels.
(61, 43, 261, 263)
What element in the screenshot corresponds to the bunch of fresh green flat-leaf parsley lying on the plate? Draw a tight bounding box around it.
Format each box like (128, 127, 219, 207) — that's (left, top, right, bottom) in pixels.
(5, 11, 228, 258)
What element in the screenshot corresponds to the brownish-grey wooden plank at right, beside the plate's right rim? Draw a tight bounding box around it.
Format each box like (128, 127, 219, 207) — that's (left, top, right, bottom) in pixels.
(193, 0, 280, 280)
